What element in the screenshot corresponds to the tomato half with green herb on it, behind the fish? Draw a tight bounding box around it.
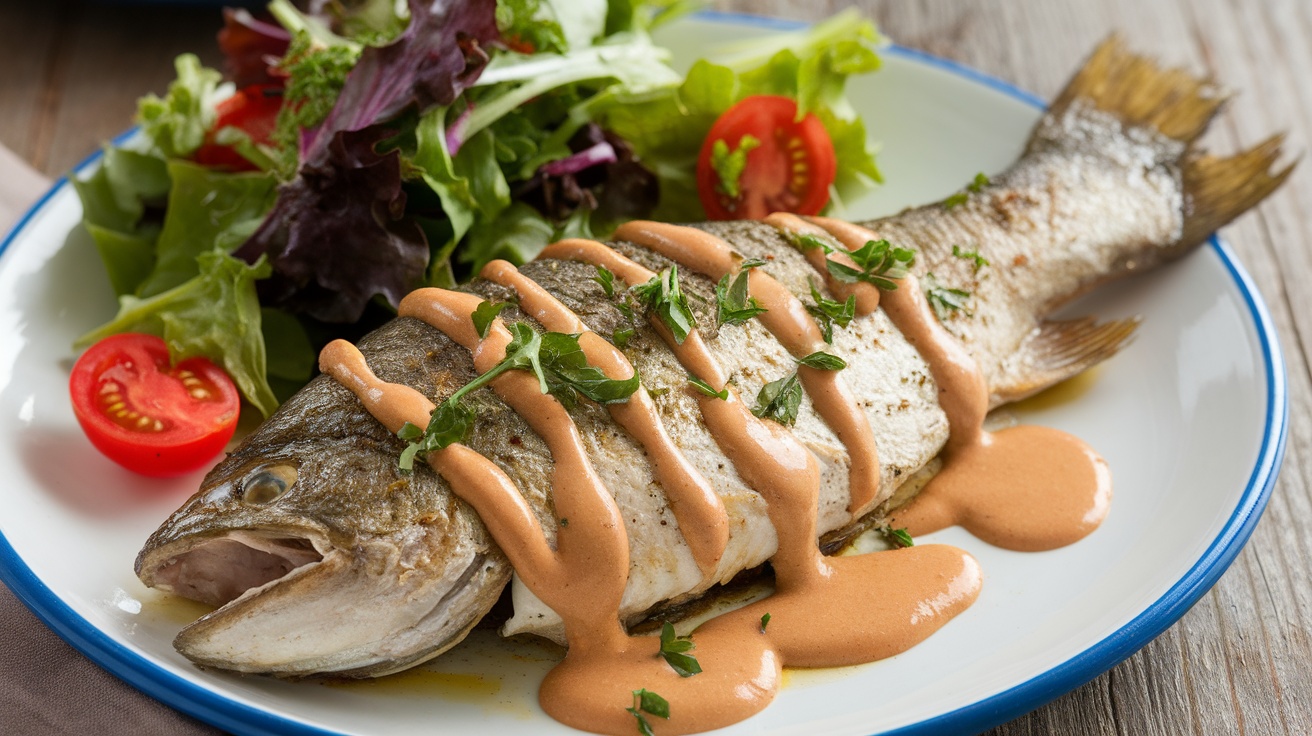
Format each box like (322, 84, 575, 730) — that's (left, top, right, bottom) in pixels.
(697, 94, 837, 219)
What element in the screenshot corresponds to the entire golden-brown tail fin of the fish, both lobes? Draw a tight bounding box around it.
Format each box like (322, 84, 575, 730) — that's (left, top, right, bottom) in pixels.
(1031, 34, 1294, 255)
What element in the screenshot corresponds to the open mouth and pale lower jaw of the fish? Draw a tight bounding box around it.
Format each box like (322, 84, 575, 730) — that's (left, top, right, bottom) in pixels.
(136, 529, 510, 678)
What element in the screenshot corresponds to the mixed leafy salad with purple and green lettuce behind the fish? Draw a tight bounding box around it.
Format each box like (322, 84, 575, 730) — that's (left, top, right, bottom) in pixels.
(73, 0, 879, 416)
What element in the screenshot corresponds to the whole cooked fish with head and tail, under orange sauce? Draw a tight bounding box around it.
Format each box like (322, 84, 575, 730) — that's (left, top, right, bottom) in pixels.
(136, 39, 1288, 677)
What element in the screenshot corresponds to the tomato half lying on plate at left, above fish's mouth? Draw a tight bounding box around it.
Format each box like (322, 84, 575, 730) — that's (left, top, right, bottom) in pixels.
(68, 332, 241, 478)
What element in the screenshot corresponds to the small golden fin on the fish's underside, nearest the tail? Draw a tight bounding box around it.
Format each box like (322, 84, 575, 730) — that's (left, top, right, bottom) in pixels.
(991, 317, 1140, 408)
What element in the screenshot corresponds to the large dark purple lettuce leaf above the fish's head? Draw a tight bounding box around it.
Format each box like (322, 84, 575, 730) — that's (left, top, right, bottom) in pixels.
(236, 0, 499, 323)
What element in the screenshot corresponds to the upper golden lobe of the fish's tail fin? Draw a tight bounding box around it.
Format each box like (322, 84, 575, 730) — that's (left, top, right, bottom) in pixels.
(1048, 34, 1227, 143)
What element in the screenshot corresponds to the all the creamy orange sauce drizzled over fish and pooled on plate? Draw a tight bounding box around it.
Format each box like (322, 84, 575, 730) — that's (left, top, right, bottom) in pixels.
(320, 216, 1110, 733)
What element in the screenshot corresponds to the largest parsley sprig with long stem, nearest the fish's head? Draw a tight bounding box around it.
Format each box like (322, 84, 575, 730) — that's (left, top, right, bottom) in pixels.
(396, 323, 639, 470)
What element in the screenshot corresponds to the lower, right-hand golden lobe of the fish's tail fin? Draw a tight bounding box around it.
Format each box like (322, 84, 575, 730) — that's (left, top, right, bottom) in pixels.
(1179, 134, 1298, 248)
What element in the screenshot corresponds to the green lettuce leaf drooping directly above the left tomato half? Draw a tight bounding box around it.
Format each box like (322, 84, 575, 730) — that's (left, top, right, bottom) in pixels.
(77, 251, 278, 416)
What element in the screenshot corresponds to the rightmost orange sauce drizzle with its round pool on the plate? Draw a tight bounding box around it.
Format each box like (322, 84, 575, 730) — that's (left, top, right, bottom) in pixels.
(811, 218, 1111, 551)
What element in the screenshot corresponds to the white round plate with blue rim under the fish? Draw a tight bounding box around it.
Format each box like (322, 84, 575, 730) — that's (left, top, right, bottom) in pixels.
(0, 16, 1287, 735)
